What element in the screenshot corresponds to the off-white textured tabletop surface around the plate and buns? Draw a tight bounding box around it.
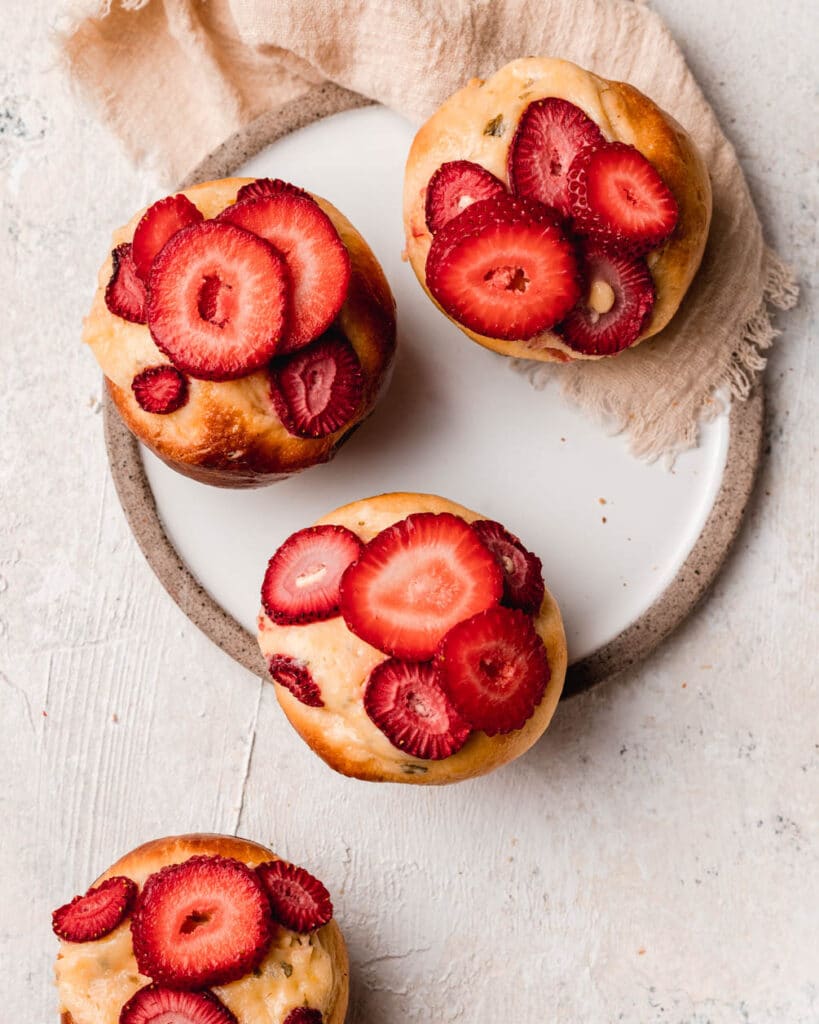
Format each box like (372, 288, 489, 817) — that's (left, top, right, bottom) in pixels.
(0, 0, 819, 1024)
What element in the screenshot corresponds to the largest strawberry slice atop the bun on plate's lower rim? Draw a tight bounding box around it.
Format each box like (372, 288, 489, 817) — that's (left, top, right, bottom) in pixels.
(341, 512, 504, 662)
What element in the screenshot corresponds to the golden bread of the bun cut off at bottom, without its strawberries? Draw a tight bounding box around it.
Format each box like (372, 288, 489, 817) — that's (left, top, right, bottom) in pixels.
(54, 834, 348, 1024)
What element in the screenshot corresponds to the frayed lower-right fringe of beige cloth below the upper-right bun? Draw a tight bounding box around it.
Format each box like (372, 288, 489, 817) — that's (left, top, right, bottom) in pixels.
(512, 247, 800, 469)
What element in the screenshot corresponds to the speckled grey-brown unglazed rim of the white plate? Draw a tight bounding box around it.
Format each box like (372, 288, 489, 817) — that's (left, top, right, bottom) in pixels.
(103, 84, 765, 697)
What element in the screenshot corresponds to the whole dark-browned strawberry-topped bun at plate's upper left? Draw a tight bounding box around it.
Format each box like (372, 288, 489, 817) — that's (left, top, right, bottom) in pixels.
(83, 178, 395, 487)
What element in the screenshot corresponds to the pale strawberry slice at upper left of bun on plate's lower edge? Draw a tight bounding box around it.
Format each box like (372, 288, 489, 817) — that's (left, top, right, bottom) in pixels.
(262, 524, 363, 626)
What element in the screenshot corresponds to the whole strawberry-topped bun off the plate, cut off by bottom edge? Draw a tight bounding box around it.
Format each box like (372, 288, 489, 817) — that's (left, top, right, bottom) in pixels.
(52, 835, 348, 1024)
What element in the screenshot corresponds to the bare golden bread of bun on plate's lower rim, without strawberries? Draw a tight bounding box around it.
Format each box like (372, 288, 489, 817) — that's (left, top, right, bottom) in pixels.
(259, 493, 567, 784)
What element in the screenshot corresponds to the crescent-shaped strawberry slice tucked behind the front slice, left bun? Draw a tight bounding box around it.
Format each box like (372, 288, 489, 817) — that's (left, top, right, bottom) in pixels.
(219, 191, 350, 354)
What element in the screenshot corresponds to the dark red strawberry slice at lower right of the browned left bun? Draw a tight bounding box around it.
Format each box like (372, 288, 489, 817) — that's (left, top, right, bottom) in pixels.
(270, 331, 364, 437)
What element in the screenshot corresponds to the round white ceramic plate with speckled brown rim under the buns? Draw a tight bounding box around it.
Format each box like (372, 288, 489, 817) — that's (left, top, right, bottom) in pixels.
(106, 87, 762, 693)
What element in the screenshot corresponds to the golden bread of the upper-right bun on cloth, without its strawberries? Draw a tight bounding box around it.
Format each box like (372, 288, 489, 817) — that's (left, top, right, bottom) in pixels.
(403, 57, 712, 361)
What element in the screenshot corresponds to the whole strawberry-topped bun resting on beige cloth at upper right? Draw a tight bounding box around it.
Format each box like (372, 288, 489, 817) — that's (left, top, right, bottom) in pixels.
(403, 57, 712, 362)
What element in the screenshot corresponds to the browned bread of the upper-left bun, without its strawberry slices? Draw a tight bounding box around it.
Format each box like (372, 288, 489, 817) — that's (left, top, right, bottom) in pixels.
(88, 178, 395, 487)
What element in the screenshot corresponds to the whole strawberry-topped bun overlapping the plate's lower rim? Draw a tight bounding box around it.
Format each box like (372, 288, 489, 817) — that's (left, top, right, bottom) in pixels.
(259, 494, 566, 784)
